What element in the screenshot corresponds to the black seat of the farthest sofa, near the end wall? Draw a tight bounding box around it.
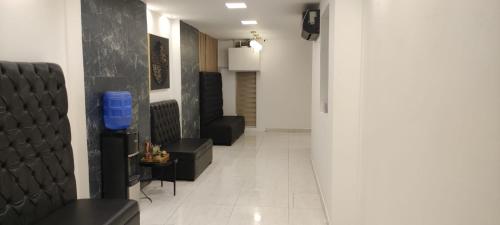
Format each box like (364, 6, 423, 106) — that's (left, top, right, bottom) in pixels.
(201, 116, 245, 145)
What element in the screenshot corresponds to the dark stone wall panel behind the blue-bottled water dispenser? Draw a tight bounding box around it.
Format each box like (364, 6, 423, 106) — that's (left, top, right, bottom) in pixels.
(81, 0, 150, 198)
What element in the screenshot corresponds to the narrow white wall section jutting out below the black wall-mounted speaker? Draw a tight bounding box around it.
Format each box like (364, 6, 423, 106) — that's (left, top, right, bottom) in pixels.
(311, 0, 363, 225)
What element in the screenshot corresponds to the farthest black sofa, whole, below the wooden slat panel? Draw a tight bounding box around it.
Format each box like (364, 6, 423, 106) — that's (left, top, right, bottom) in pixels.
(200, 72, 245, 145)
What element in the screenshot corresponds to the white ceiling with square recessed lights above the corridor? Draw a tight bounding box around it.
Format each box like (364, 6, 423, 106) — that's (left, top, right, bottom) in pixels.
(143, 0, 319, 40)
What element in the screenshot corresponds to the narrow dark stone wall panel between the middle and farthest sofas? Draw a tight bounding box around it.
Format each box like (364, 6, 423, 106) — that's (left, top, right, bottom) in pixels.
(180, 21, 200, 138)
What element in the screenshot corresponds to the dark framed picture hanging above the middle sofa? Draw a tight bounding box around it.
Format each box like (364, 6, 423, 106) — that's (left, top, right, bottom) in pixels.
(149, 34, 170, 90)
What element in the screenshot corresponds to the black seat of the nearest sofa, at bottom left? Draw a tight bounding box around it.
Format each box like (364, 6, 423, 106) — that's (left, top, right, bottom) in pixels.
(36, 199, 139, 225)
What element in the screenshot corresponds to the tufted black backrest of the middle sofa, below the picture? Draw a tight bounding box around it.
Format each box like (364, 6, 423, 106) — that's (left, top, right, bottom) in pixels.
(150, 100, 181, 145)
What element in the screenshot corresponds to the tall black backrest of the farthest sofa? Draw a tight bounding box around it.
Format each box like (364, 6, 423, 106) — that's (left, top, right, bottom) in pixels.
(200, 72, 224, 125)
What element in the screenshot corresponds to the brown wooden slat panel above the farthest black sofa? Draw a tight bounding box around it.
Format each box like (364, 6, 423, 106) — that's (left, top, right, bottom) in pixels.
(198, 32, 219, 72)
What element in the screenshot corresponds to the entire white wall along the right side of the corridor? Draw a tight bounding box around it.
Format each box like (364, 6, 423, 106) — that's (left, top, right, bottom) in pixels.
(311, 0, 500, 225)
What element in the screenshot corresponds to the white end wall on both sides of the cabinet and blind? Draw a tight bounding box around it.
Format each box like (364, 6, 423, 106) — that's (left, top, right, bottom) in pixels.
(219, 40, 312, 130)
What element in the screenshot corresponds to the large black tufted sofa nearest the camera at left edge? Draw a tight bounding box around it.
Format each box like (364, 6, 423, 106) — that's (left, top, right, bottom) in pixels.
(0, 61, 140, 225)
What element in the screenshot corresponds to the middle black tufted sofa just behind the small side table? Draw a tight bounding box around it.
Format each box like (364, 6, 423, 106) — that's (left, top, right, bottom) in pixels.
(150, 100, 213, 181)
